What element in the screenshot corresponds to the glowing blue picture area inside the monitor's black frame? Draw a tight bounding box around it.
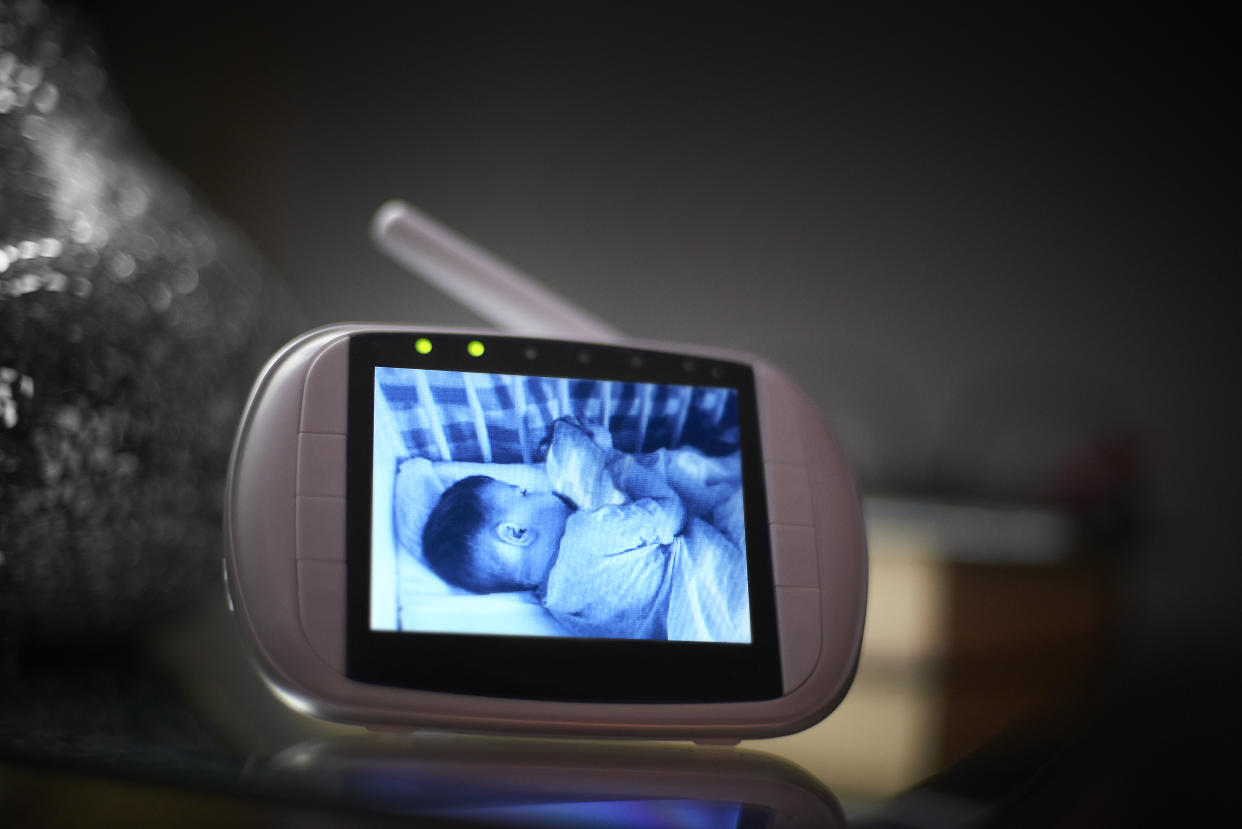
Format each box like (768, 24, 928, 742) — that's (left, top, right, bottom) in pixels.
(369, 365, 751, 644)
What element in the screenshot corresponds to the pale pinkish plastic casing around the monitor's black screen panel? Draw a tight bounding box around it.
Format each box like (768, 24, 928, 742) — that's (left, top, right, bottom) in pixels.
(225, 324, 867, 742)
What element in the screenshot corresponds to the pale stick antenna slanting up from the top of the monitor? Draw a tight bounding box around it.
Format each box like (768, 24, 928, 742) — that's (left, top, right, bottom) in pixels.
(371, 201, 621, 342)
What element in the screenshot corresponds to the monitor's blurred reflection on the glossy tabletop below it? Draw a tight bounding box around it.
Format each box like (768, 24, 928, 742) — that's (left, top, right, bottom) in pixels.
(257, 735, 846, 829)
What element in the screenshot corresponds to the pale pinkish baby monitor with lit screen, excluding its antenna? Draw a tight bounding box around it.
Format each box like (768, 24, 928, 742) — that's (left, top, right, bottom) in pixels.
(227, 326, 866, 738)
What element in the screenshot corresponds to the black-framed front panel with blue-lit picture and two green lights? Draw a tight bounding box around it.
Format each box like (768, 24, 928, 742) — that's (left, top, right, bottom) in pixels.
(345, 333, 781, 702)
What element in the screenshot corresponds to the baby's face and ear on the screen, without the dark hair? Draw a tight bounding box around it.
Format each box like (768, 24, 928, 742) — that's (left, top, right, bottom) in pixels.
(479, 481, 571, 588)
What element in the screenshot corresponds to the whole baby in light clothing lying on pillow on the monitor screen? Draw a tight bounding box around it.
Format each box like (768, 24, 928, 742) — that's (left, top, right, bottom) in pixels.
(422, 420, 687, 639)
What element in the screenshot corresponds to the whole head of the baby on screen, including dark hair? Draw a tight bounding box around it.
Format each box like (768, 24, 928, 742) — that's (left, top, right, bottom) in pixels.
(422, 475, 573, 593)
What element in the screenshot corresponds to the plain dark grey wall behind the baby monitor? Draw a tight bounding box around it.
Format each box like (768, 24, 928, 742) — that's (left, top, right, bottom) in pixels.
(83, 2, 1242, 659)
